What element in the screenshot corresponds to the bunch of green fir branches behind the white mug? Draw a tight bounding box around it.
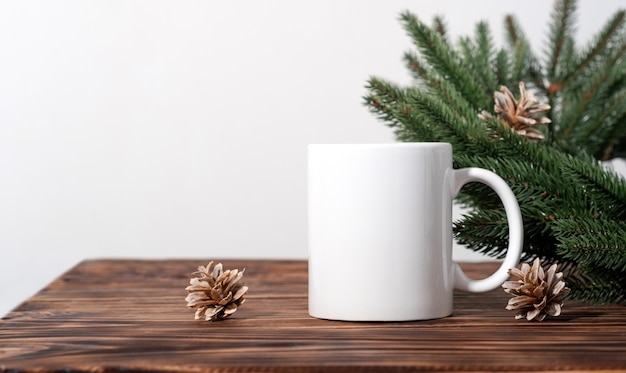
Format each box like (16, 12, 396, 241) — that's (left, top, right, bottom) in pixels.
(365, 0, 626, 302)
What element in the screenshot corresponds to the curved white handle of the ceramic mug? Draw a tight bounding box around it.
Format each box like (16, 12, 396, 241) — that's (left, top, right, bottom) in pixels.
(453, 167, 524, 293)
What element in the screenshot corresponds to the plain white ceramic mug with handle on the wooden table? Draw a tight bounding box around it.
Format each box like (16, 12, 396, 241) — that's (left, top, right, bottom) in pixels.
(308, 143, 523, 321)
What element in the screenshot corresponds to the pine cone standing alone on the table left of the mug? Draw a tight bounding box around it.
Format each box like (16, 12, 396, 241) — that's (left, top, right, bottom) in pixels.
(185, 261, 248, 321)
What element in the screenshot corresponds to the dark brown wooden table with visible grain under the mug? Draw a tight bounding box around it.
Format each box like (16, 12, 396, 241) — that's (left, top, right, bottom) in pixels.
(0, 260, 626, 372)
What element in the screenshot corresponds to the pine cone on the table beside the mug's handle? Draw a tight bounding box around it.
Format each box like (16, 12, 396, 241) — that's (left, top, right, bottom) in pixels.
(502, 258, 570, 321)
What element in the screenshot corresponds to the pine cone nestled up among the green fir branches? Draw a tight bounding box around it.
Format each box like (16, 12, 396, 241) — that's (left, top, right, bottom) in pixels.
(478, 82, 552, 139)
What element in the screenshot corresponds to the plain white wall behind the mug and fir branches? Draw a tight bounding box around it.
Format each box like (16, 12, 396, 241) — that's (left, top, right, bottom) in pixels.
(0, 0, 626, 314)
